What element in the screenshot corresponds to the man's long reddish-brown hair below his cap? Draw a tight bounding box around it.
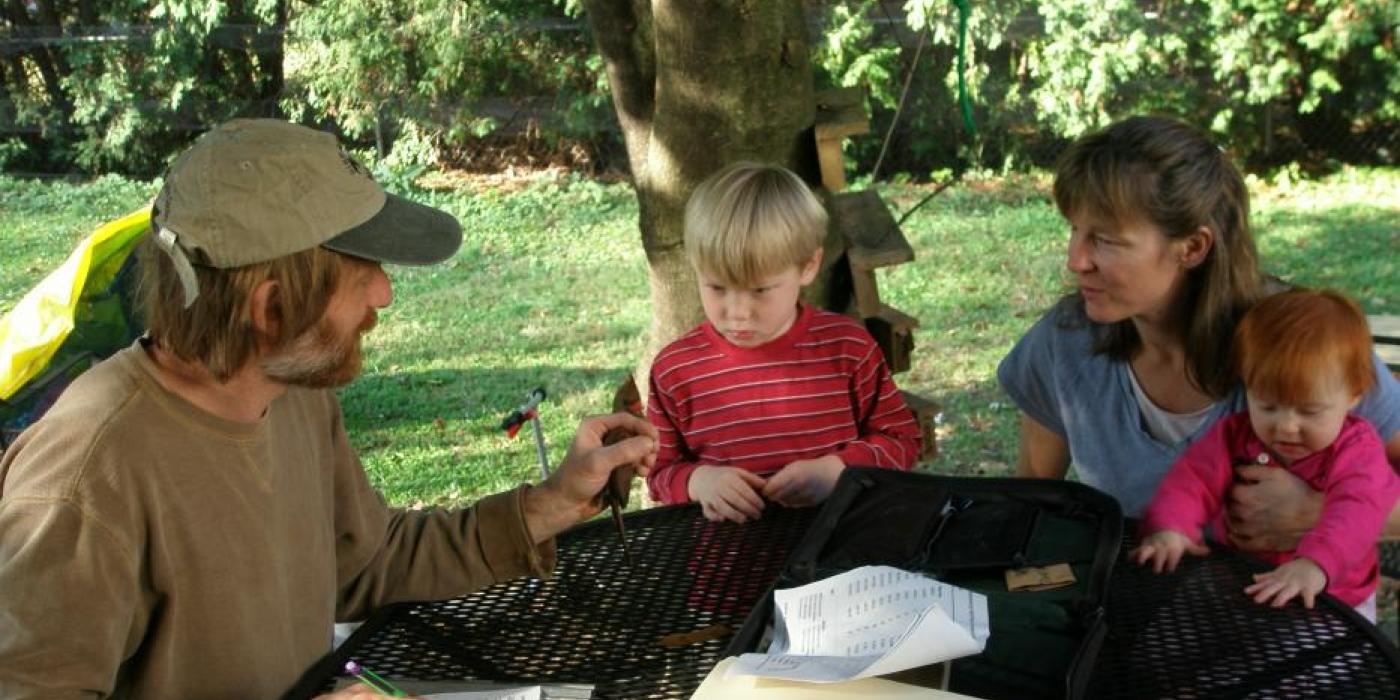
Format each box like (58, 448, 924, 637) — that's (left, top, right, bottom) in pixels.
(136, 237, 342, 382)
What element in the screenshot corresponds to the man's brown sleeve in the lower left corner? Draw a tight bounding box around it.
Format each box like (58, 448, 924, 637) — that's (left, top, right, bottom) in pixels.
(0, 496, 146, 699)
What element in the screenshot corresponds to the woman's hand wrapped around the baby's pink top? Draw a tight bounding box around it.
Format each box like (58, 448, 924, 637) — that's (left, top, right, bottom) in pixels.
(1228, 465, 1323, 552)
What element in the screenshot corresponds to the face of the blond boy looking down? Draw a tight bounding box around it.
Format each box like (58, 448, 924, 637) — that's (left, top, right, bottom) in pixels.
(696, 251, 822, 347)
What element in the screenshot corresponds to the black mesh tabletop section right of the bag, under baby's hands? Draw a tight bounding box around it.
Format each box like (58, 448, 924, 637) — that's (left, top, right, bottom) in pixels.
(1089, 526, 1400, 700)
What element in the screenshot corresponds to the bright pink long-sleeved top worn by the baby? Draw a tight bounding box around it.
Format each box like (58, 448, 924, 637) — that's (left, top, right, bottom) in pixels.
(1140, 412, 1400, 606)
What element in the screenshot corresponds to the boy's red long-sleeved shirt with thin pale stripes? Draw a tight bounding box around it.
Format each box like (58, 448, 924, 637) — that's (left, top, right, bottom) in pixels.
(647, 304, 921, 503)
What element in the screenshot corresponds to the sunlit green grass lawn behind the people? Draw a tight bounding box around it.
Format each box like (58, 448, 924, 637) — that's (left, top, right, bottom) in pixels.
(0, 169, 1400, 504)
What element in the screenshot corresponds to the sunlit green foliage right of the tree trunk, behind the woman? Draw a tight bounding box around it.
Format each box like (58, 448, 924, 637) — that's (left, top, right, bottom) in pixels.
(813, 0, 1400, 172)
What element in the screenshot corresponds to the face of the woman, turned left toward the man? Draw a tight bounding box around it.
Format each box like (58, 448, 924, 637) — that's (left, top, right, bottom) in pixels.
(1065, 213, 1187, 323)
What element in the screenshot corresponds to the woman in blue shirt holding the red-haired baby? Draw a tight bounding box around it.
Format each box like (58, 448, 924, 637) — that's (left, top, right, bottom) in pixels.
(997, 116, 1400, 550)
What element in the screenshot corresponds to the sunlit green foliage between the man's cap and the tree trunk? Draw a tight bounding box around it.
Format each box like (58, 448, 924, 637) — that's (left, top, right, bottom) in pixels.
(283, 0, 606, 155)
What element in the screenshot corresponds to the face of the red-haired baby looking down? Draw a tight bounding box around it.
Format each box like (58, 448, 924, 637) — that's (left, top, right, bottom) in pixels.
(1246, 368, 1361, 465)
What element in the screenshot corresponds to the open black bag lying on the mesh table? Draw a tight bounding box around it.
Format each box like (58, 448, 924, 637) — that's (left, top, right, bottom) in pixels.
(725, 468, 1123, 699)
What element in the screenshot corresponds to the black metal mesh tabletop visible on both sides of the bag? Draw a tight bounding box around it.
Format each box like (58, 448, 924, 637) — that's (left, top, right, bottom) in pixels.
(287, 505, 1400, 700)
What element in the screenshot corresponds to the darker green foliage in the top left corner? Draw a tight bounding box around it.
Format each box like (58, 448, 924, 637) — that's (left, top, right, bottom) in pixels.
(4, 0, 281, 174)
